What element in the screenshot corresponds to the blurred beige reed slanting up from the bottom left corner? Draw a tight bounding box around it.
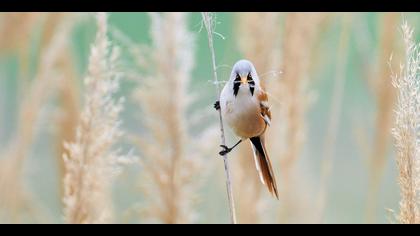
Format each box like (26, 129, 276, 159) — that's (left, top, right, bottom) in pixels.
(0, 12, 75, 222)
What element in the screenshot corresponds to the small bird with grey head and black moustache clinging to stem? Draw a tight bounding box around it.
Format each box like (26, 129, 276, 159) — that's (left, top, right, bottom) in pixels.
(214, 60, 278, 199)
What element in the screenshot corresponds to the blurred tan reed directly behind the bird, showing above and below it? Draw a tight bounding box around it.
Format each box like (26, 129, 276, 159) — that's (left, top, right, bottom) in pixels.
(233, 12, 280, 224)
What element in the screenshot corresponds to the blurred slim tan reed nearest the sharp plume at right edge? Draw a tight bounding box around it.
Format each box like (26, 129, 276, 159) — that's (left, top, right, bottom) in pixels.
(366, 13, 399, 223)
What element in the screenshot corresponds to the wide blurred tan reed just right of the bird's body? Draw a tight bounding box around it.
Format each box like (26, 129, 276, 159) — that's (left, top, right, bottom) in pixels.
(276, 13, 324, 222)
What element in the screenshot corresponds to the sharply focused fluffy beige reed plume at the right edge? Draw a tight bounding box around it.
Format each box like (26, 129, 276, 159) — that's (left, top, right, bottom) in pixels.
(391, 21, 420, 224)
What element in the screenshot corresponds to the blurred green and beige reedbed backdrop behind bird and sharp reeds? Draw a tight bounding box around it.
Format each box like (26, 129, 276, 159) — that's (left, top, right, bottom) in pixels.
(0, 13, 420, 223)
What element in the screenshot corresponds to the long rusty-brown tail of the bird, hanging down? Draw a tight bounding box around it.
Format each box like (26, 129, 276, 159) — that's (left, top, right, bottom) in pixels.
(250, 136, 279, 199)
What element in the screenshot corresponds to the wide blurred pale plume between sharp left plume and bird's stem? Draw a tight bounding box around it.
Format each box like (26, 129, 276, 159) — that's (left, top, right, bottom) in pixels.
(134, 13, 209, 223)
